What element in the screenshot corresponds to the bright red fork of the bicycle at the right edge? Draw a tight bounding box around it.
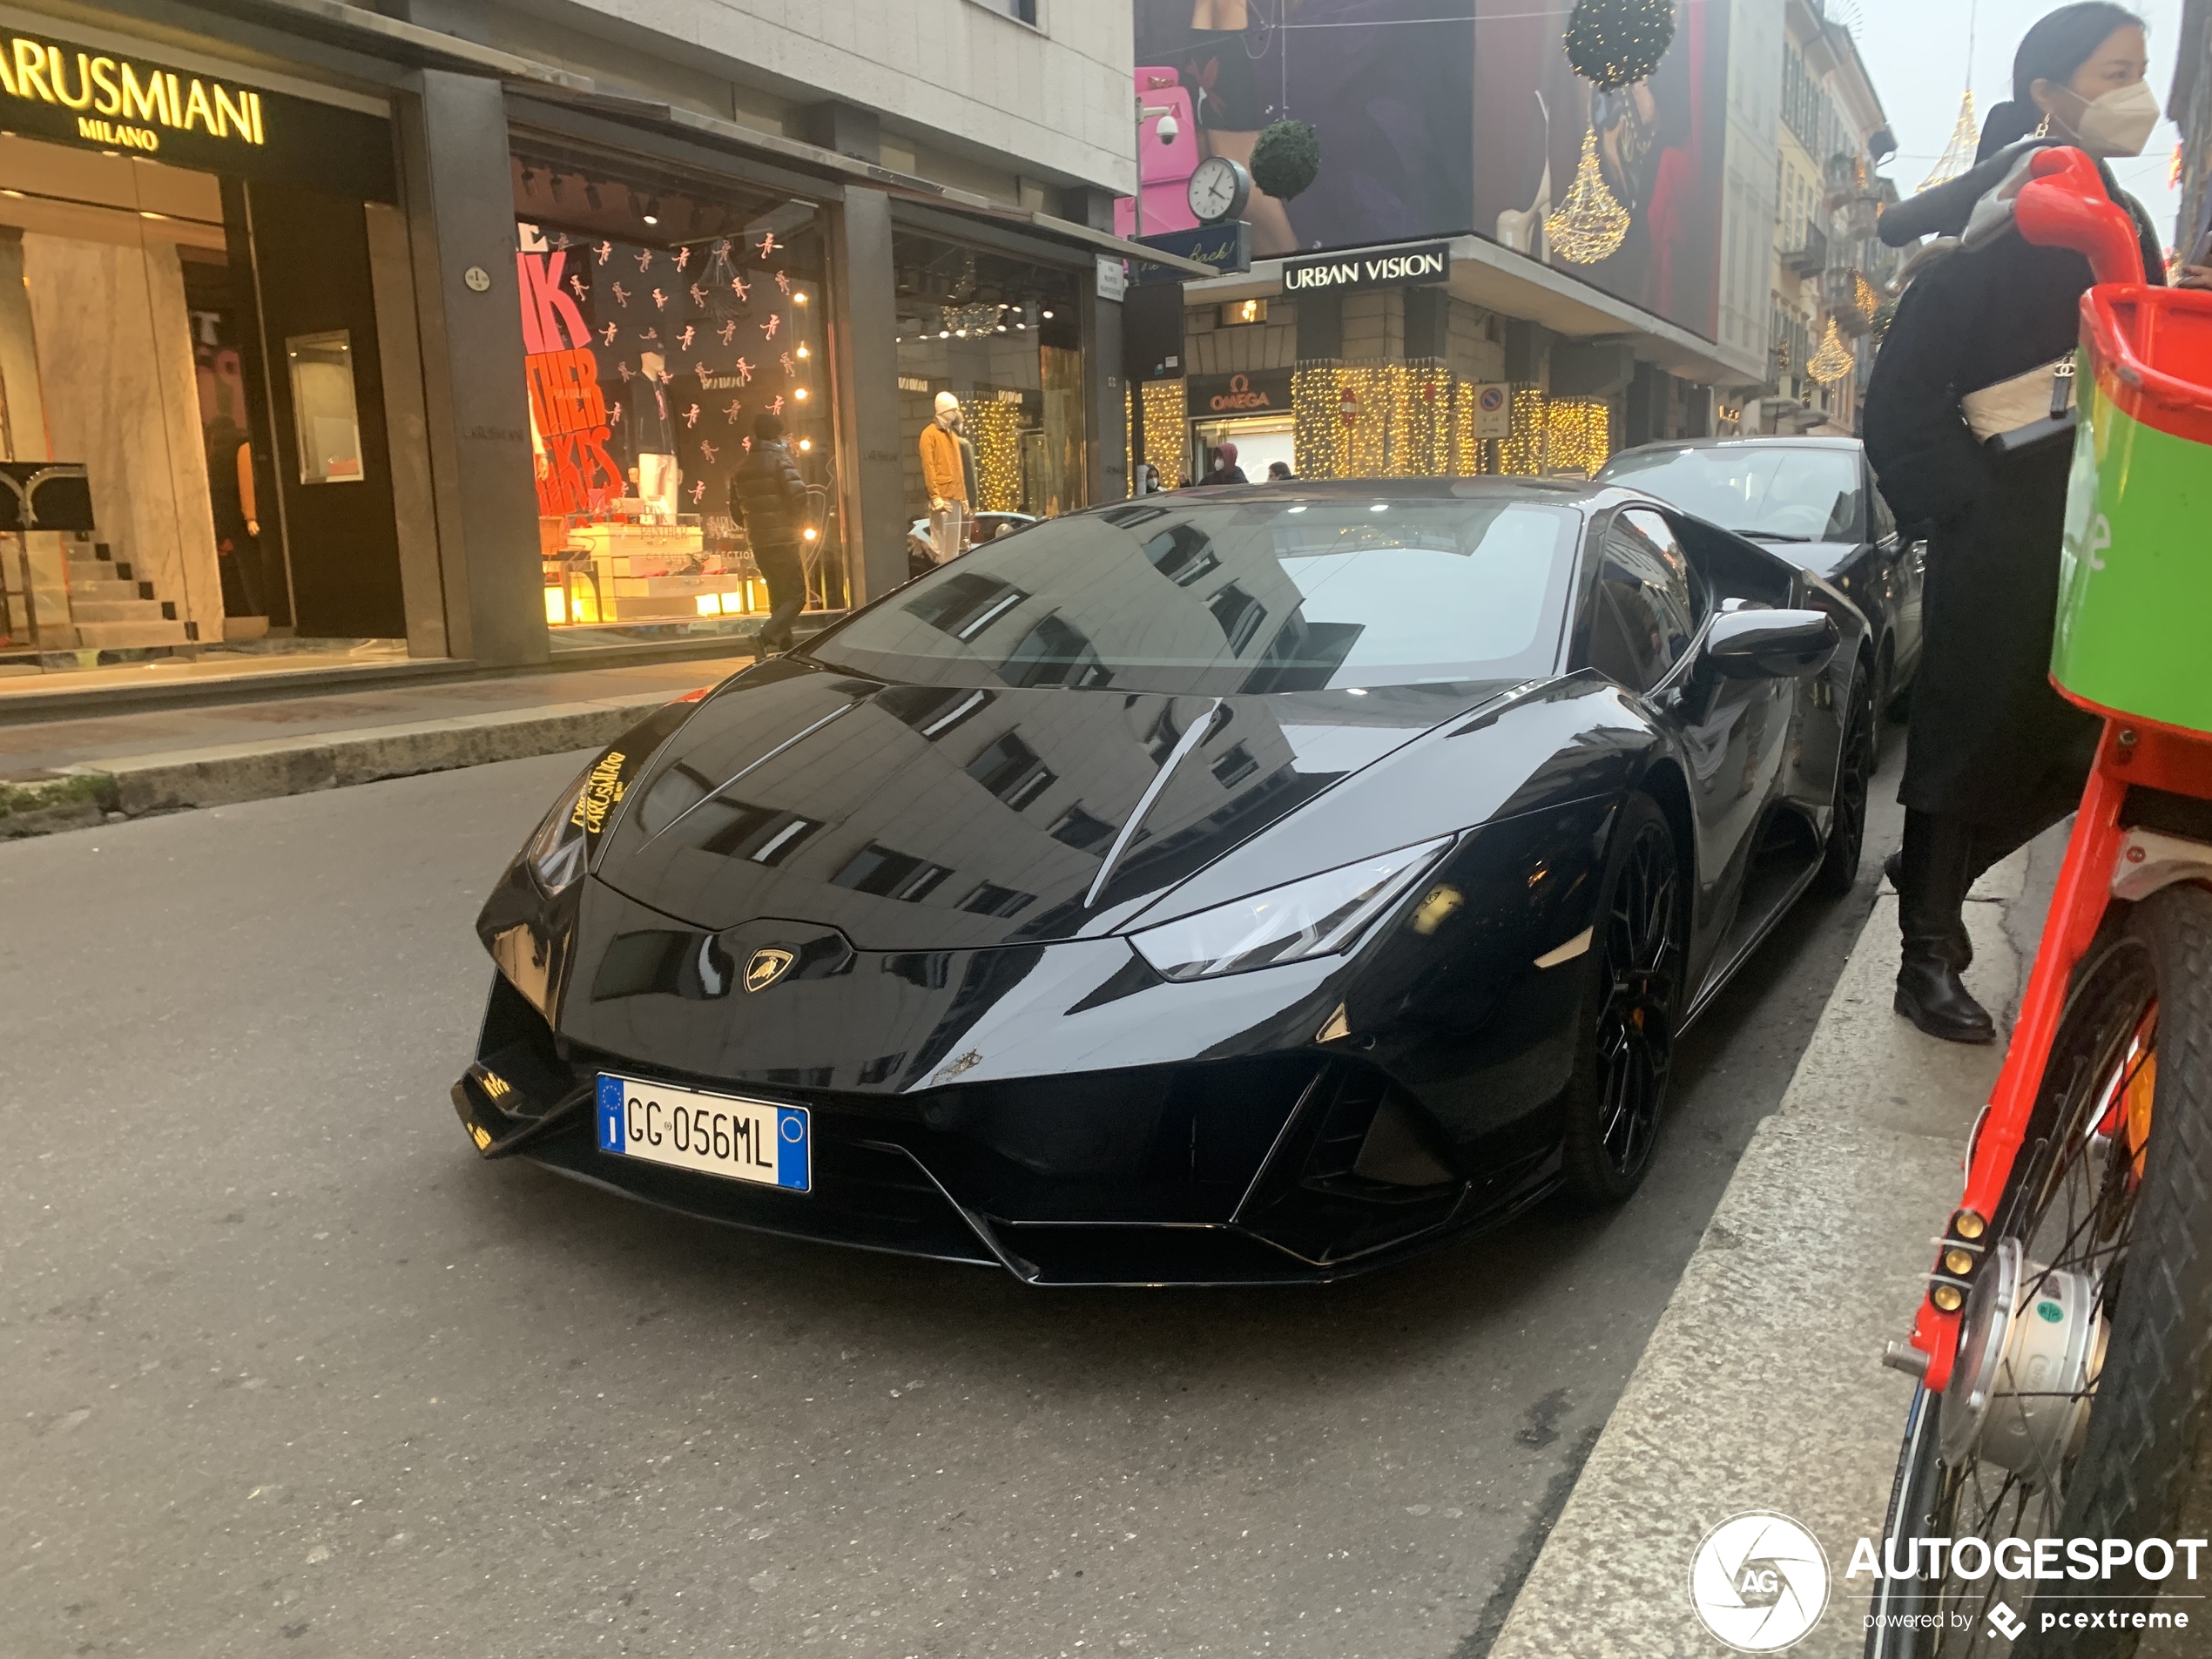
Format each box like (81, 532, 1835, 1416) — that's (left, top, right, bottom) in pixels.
(1893, 721, 2212, 1393)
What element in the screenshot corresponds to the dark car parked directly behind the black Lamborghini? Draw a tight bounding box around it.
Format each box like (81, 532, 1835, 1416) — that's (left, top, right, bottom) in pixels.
(1599, 438, 1926, 712)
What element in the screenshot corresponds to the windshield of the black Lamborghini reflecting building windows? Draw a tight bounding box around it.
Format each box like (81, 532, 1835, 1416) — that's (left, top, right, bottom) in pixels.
(806, 498, 1581, 697)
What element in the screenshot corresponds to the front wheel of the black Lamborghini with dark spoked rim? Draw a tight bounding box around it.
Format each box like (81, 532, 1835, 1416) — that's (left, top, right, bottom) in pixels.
(1561, 794, 1688, 1208)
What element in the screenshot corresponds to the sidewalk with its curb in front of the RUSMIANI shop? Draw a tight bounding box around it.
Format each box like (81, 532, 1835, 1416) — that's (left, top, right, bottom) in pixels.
(0, 655, 752, 839)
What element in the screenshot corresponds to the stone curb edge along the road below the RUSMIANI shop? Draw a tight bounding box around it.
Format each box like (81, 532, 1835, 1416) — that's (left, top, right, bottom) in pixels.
(0, 695, 668, 839)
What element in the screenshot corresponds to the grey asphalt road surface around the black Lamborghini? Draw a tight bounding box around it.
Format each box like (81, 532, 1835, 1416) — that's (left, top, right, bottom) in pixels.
(0, 741, 1898, 1659)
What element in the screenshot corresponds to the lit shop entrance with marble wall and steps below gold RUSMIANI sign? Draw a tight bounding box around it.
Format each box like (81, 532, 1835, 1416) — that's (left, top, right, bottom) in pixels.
(0, 71, 413, 692)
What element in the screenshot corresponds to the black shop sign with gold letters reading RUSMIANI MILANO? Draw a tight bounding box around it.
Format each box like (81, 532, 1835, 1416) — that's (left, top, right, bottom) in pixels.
(0, 33, 396, 201)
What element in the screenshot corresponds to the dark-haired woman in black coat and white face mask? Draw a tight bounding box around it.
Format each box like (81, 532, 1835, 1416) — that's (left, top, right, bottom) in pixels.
(1865, 0, 2163, 1042)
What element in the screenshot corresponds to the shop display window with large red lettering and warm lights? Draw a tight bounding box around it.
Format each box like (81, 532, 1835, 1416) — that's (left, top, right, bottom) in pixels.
(513, 137, 845, 646)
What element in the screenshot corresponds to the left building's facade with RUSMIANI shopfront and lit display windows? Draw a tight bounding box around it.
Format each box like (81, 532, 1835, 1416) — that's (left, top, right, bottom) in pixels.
(0, 0, 1195, 690)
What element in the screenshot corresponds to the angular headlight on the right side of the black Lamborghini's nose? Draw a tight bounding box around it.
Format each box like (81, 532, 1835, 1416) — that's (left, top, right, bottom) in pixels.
(1128, 836, 1451, 980)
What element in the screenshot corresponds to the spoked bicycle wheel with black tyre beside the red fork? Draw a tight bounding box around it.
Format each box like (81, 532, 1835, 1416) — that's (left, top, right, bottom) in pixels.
(1867, 887, 2212, 1659)
